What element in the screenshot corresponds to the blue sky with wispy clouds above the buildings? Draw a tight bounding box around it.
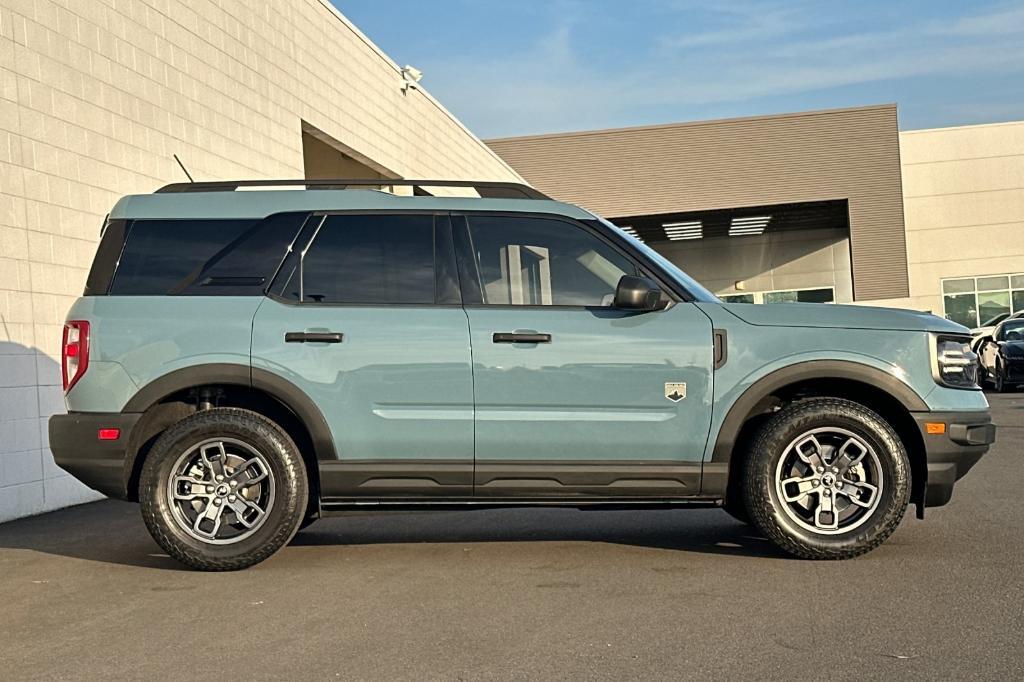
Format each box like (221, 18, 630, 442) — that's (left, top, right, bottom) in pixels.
(334, 0, 1024, 137)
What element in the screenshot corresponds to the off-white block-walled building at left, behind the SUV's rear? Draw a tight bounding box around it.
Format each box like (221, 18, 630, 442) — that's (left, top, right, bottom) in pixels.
(0, 0, 519, 521)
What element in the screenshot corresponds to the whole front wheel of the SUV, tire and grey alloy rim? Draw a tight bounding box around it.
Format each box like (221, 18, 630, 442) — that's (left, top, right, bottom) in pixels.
(745, 398, 910, 559)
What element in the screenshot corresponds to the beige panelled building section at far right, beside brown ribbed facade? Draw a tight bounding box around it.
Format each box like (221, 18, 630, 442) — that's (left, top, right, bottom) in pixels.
(893, 122, 1024, 324)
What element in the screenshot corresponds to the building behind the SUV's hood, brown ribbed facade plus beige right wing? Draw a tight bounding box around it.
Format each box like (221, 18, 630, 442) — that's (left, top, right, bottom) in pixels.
(488, 104, 1024, 327)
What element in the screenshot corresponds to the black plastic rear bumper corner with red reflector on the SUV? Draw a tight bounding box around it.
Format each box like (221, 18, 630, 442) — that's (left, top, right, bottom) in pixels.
(49, 412, 142, 500)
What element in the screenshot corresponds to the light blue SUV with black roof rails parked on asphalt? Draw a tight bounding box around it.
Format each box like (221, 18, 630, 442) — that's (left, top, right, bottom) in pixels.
(50, 180, 994, 570)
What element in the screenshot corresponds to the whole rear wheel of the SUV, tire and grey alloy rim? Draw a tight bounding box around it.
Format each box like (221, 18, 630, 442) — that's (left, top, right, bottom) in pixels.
(139, 409, 308, 570)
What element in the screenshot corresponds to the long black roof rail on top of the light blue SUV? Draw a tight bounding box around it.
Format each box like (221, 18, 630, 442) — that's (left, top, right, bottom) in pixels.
(156, 178, 551, 199)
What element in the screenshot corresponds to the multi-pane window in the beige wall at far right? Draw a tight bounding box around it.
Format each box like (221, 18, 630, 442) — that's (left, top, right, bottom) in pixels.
(942, 273, 1024, 327)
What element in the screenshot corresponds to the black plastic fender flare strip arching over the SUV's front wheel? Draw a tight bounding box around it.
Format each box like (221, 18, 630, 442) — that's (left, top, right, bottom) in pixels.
(711, 360, 929, 464)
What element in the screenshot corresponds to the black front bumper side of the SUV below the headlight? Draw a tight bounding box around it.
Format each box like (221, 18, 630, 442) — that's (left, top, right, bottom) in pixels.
(913, 410, 995, 503)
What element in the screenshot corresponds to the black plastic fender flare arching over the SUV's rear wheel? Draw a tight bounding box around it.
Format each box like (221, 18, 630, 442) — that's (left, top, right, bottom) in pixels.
(121, 363, 338, 461)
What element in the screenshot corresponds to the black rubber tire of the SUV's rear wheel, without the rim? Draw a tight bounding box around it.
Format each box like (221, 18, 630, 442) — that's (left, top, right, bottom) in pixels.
(139, 408, 308, 570)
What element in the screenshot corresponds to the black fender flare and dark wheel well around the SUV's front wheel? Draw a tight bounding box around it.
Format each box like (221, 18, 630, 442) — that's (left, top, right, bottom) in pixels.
(708, 360, 929, 515)
